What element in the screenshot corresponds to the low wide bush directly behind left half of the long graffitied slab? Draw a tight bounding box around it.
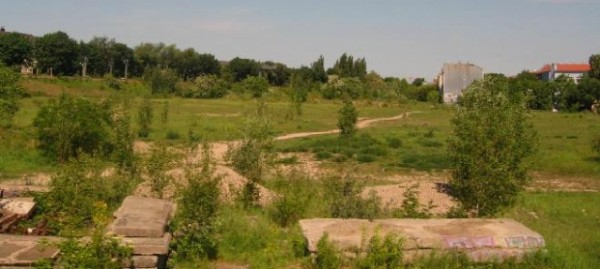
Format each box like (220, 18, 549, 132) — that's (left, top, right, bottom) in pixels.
(323, 176, 381, 219)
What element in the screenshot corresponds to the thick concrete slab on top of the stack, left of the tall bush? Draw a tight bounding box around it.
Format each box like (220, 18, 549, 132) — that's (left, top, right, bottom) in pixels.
(109, 196, 173, 237)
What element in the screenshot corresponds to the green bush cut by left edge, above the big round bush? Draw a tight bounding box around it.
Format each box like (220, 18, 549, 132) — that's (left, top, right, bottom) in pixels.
(0, 65, 24, 128)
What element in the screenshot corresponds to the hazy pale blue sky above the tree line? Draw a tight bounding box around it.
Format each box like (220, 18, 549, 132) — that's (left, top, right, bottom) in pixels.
(0, 0, 600, 78)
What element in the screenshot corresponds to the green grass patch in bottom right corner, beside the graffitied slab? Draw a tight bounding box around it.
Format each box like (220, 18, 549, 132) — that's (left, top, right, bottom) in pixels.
(506, 192, 600, 268)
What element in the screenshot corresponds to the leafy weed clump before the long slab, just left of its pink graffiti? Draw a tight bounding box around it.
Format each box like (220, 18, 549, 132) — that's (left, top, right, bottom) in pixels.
(355, 233, 404, 269)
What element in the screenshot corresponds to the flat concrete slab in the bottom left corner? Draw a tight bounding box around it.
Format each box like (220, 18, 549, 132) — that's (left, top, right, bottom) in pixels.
(0, 234, 59, 268)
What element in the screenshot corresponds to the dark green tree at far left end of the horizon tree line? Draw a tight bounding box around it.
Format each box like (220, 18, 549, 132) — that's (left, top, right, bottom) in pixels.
(0, 33, 33, 66)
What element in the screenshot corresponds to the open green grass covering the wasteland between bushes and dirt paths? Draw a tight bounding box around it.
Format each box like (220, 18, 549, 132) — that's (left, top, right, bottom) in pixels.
(0, 78, 600, 268)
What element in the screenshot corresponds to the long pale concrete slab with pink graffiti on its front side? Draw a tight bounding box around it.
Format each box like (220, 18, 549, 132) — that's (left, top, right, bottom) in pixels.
(300, 219, 545, 261)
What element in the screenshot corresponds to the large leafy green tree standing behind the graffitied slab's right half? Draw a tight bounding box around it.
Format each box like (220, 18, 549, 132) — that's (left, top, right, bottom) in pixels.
(448, 79, 536, 216)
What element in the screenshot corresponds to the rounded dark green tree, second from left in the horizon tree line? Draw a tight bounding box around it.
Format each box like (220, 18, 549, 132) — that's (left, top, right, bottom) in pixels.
(34, 31, 79, 75)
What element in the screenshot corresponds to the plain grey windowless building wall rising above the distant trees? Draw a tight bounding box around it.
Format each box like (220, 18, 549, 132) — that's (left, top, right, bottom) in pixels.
(437, 63, 483, 103)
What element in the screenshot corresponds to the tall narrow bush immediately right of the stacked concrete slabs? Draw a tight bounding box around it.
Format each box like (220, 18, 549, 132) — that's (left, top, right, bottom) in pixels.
(172, 143, 219, 260)
